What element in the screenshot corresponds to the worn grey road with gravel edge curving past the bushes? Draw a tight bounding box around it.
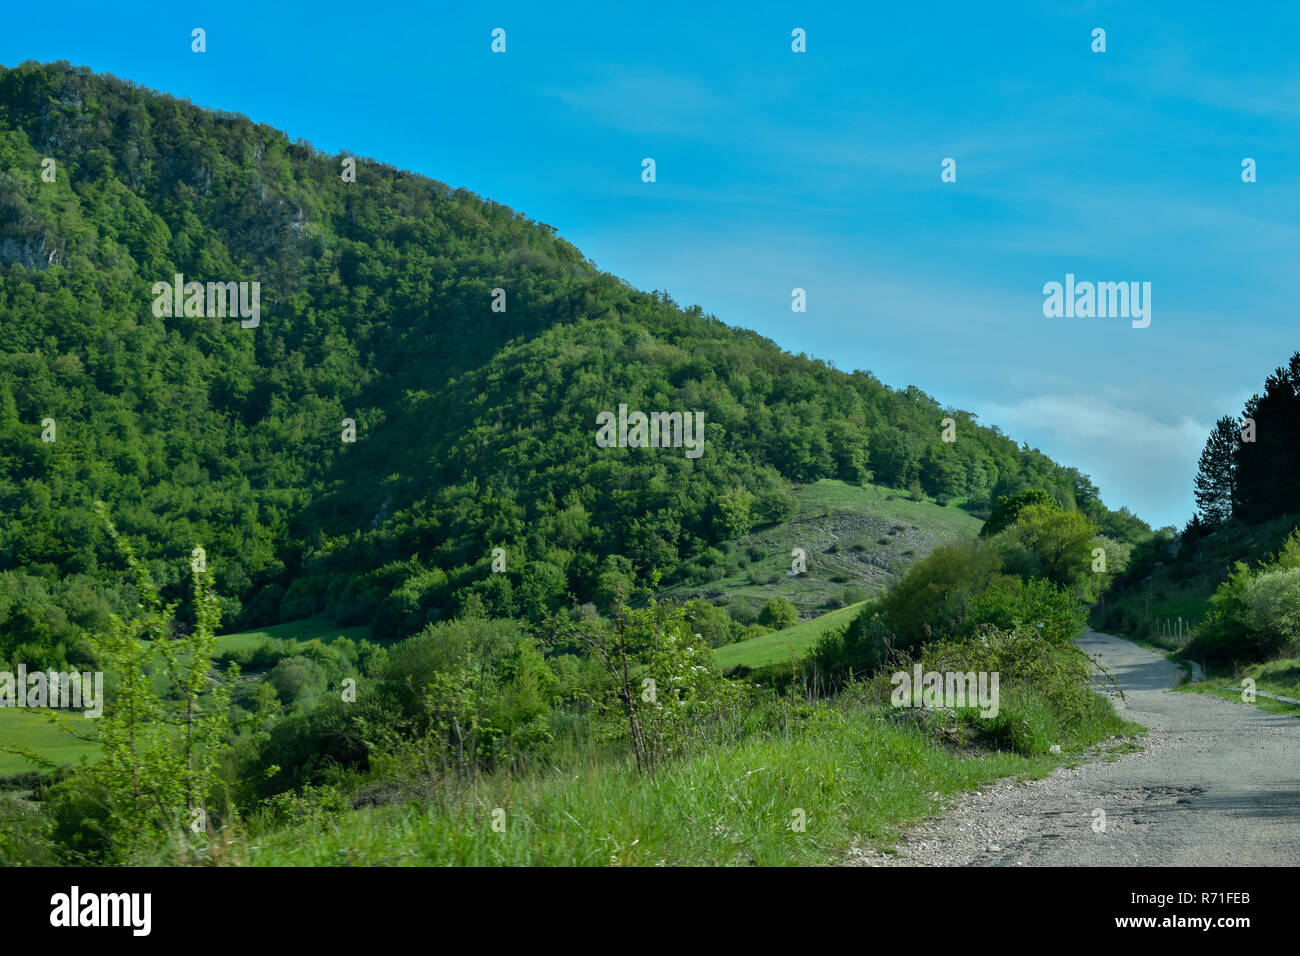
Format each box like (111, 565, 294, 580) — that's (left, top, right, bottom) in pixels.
(846, 631, 1300, 866)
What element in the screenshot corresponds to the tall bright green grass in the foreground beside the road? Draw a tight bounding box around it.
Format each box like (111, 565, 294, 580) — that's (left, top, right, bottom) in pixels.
(241, 709, 1063, 866)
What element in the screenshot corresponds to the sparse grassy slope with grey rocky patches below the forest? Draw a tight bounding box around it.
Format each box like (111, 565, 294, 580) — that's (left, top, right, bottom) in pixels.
(662, 479, 983, 620)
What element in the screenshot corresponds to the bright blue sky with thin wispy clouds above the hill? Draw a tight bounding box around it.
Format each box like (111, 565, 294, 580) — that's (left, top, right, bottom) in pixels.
(0, 0, 1300, 525)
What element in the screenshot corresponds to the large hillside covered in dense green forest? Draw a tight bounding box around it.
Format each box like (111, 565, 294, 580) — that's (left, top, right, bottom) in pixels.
(0, 64, 1147, 666)
